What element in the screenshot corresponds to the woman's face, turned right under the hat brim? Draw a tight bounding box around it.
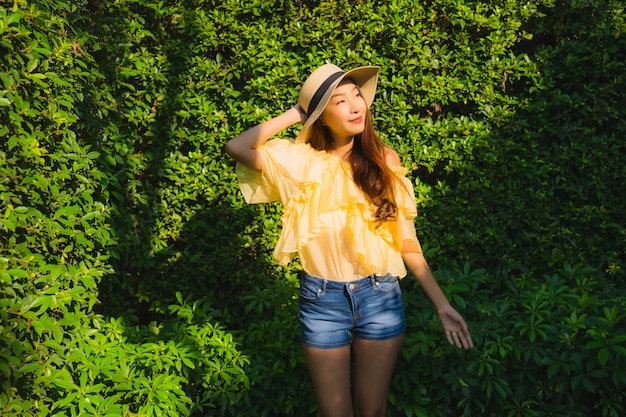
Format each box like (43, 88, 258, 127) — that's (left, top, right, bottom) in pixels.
(320, 79, 367, 142)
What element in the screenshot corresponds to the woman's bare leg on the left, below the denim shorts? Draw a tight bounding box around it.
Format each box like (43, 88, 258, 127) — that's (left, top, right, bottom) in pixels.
(304, 346, 354, 417)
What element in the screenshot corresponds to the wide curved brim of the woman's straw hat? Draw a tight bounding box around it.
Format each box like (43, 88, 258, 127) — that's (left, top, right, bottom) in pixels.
(296, 66, 380, 143)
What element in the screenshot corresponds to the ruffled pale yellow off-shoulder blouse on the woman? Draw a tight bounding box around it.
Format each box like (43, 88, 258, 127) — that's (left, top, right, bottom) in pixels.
(237, 139, 421, 281)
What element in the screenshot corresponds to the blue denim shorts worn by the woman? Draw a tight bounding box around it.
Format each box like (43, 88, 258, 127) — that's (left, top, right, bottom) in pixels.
(299, 272, 406, 349)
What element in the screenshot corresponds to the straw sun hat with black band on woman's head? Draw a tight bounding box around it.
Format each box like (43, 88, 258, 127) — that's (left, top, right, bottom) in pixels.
(296, 64, 379, 142)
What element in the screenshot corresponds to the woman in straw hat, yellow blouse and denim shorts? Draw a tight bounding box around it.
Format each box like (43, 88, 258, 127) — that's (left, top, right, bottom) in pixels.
(226, 64, 473, 417)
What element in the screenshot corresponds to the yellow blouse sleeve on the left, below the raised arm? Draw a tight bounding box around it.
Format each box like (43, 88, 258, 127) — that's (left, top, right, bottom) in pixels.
(236, 139, 315, 204)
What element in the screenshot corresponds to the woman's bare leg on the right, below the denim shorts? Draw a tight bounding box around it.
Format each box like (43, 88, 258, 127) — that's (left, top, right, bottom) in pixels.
(354, 335, 404, 417)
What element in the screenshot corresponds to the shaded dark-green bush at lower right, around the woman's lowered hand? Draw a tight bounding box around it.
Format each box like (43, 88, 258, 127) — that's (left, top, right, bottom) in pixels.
(392, 263, 626, 416)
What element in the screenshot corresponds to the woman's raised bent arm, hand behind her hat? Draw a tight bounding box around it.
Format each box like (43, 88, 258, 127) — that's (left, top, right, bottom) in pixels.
(225, 105, 306, 171)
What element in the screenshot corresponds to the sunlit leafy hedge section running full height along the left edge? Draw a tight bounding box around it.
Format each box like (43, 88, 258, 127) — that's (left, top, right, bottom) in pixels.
(0, 3, 115, 415)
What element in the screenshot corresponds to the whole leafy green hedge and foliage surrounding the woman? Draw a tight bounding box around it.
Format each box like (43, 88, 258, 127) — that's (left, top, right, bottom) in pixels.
(0, 0, 626, 417)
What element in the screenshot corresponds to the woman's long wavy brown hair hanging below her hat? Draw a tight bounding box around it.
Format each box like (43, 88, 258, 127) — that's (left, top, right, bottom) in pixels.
(307, 110, 398, 225)
